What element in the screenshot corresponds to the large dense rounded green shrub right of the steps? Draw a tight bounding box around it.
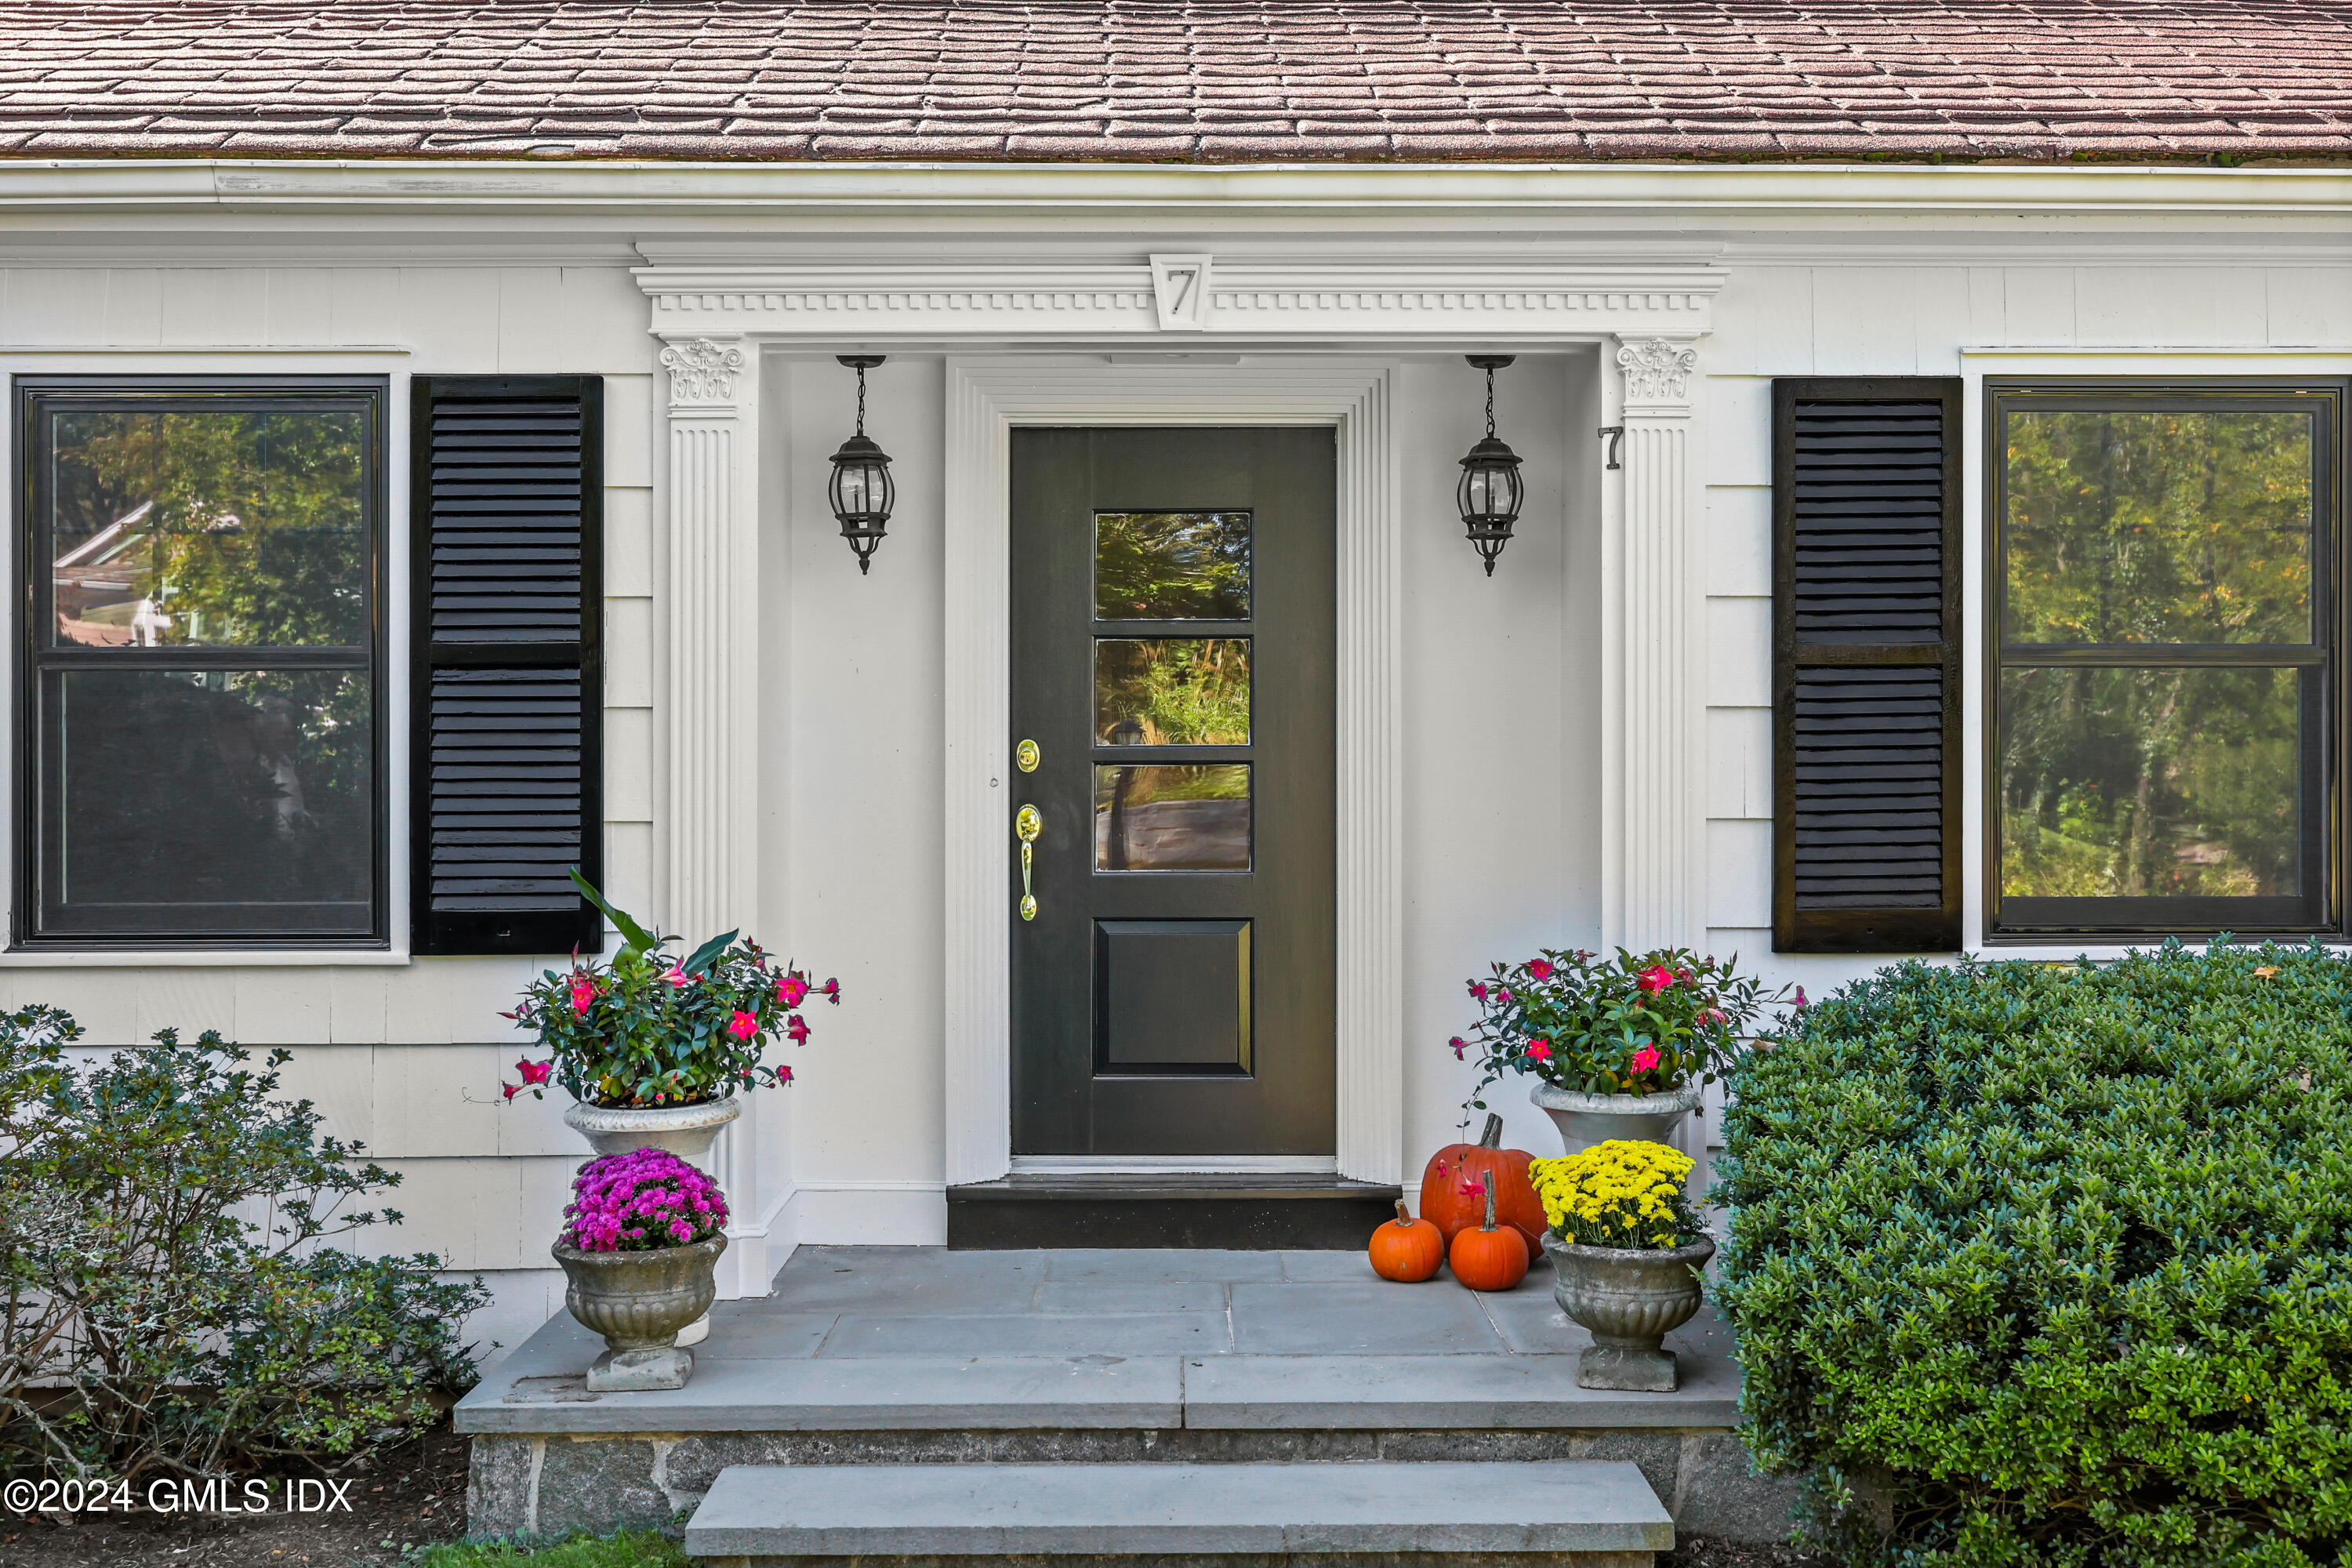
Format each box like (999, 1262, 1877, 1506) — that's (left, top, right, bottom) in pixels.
(1717, 945, 2352, 1568)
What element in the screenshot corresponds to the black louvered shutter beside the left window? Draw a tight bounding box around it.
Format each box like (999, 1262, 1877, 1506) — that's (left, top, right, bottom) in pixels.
(409, 376, 604, 954)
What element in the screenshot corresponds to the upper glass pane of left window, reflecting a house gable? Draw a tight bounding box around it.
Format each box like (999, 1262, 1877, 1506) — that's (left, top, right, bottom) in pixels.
(47, 409, 367, 647)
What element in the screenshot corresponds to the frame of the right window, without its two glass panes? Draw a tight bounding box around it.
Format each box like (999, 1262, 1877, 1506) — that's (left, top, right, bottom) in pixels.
(1980, 376, 2352, 947)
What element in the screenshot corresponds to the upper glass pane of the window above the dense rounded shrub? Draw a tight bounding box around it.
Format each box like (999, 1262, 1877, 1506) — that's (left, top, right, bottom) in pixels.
(2004, 409, 2317, 644)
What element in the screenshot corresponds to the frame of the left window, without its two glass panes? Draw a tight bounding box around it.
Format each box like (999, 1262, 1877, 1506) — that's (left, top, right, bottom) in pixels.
(7, 374, 393, 954)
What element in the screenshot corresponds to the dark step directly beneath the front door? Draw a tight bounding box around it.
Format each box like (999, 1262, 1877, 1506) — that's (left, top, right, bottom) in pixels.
(948, 1175, 1402, 1250)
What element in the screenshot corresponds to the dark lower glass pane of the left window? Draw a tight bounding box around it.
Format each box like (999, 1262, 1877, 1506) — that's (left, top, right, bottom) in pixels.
(45, 670, 374, 933)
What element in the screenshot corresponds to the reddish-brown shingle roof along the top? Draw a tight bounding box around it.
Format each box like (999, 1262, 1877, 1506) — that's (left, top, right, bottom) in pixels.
(0, 0, 2352, 162)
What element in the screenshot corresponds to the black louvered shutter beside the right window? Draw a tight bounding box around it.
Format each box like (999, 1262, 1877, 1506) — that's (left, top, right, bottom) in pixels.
(1771, 376, 1962, 952)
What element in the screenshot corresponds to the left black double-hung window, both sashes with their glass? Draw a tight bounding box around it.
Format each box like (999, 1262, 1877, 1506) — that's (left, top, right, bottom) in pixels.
(26, 383, 381, 940)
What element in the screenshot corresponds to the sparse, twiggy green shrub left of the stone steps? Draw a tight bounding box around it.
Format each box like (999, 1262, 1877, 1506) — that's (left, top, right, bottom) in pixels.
(0, 1008, 489, 1483)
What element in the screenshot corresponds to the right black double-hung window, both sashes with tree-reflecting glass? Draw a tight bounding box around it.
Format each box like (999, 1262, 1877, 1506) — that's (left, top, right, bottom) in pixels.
(1994, 390, 2331, 928)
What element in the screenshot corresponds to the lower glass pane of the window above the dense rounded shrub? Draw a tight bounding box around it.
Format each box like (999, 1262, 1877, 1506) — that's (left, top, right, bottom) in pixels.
(2002, 668, 2305, 898)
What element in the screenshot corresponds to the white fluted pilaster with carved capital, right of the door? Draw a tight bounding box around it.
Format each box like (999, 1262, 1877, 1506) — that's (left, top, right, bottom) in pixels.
(1602, 334, 1708, 952)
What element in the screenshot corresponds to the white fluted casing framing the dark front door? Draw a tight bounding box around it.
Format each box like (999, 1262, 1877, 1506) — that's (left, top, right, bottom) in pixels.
(943, 360, 1404, 1185)
